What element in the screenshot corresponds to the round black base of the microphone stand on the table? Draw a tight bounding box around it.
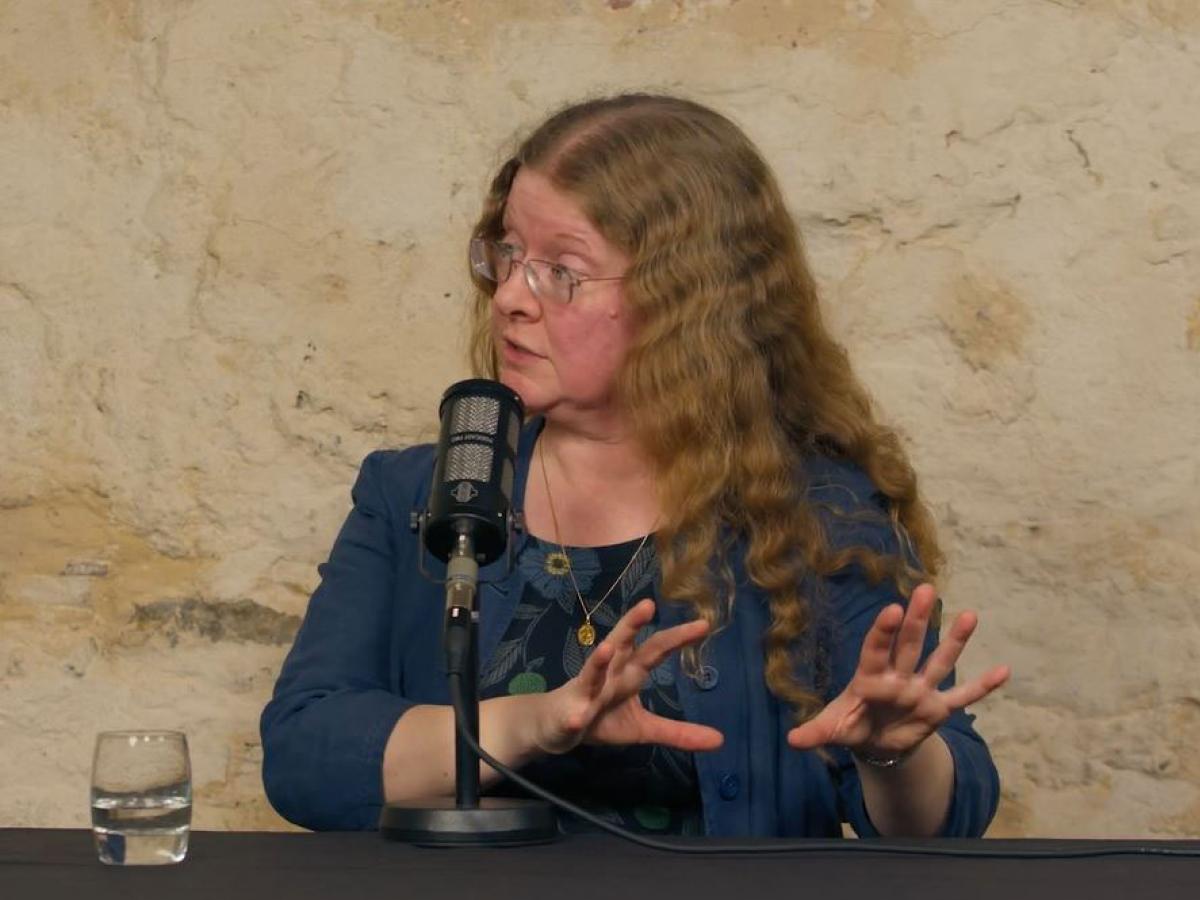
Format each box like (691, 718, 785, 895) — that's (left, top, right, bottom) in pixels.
(379, 797, 559, 847)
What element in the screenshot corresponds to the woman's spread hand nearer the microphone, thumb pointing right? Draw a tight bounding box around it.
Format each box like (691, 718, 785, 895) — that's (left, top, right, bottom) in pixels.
(535, 600, 724, 754)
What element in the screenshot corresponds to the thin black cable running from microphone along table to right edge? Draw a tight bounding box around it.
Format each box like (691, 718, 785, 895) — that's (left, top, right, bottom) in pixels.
(449, 673, 1200, 859)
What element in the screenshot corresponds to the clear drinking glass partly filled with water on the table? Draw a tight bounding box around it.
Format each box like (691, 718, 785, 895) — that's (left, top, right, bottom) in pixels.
(91, 731, 192, 865)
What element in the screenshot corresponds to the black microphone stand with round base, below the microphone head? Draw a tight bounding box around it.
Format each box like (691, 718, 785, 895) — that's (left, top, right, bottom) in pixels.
(379, 523, 558, 847)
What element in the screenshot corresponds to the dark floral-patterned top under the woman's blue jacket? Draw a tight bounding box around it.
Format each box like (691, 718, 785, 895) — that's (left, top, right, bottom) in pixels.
(479, 535, 703, 834)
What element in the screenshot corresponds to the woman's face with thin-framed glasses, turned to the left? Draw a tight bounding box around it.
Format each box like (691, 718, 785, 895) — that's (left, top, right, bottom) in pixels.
(492, 168, 632, 421)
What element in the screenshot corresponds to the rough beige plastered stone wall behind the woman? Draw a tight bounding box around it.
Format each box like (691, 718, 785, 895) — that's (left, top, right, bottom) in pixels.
(0, 0, 1200, 836)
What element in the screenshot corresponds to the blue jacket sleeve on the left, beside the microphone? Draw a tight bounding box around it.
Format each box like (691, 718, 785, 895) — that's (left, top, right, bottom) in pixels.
(260, 452, 414, 829)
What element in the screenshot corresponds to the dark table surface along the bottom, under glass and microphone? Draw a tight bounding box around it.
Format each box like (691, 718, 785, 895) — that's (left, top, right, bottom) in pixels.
(0, 828, 1200, 900)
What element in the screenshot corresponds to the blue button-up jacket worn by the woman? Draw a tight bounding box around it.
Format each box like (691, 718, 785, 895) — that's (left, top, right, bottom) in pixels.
(262, 421, 1000, 836)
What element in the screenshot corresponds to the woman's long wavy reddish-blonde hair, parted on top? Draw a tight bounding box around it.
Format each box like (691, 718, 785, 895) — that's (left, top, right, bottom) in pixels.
(472, 94, 942, 719)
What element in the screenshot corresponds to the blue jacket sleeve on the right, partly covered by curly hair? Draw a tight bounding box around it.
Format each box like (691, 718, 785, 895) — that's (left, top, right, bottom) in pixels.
(814, 476, 1000, 838)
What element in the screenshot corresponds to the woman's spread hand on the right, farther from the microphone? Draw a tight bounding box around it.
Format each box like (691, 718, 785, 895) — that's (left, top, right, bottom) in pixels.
(787, 584, 1009, 757)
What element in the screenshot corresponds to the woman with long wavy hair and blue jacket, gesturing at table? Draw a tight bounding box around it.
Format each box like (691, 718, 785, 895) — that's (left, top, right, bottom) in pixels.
(263, 95, 1008, 835)
